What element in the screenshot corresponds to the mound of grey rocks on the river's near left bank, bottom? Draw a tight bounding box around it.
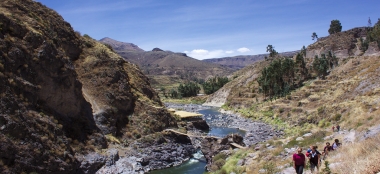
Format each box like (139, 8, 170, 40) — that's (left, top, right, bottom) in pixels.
(97, 132, 196, 174)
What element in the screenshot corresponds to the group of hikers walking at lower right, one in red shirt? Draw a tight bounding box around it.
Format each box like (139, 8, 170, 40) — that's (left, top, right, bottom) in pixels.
(293, 139, 342, 174)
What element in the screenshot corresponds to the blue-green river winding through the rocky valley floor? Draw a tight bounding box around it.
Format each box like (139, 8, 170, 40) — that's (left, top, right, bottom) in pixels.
(149, 108, 245, 174)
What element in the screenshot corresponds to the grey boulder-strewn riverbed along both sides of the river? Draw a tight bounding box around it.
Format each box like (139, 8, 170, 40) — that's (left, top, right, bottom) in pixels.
(90, 103, 283, 174)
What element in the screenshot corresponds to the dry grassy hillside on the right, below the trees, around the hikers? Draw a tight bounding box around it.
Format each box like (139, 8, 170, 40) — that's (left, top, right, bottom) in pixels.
(206, 51, 380, 173)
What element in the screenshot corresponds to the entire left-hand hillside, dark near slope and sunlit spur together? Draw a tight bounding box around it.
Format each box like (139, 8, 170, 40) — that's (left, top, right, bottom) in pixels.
(0, 0, 176, 173)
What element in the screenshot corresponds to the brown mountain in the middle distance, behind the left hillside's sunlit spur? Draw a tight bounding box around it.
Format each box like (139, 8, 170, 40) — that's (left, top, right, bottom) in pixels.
(102, 39, 234, 86)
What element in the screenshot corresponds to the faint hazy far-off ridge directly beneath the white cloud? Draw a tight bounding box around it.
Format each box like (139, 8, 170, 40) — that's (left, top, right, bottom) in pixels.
(203, 51, 299, 70)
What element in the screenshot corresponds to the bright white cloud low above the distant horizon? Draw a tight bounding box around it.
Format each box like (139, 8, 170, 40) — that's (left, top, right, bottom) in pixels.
(184, 49, 234, 60)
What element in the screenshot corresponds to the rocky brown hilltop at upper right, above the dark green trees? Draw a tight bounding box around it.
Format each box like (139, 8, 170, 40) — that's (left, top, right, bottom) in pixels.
(306, 27, 379, 58)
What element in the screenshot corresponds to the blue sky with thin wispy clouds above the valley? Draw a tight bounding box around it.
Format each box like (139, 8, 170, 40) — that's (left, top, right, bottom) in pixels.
(37, 0, 380, 59)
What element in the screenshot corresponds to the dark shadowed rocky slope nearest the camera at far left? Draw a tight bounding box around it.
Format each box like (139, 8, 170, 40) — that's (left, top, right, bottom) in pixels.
(0, 0, 106, 173)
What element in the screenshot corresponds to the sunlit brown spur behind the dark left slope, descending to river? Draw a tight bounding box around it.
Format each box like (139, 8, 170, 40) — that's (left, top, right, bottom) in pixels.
(75, 37, 175, 136)
